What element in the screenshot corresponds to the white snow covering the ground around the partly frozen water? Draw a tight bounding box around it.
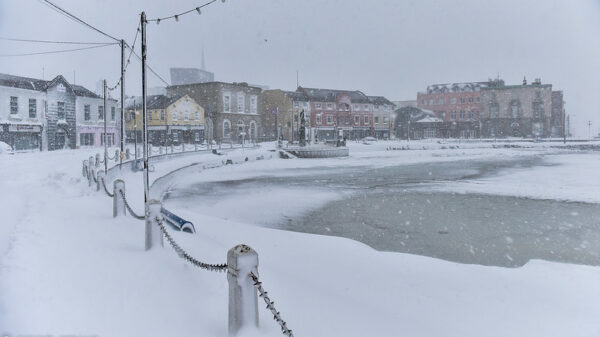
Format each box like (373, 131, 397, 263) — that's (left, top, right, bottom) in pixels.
(0, 142, 600, 337)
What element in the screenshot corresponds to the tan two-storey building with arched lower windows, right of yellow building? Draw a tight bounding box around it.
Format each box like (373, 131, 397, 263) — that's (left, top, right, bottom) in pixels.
(167, 82, 262, 142)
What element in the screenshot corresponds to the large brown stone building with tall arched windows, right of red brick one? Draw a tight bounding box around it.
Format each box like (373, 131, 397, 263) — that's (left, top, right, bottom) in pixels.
(481, 79, 552, 138)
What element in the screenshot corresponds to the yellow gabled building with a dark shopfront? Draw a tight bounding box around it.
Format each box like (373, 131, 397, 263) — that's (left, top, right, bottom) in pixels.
(125, 95, 205, 145)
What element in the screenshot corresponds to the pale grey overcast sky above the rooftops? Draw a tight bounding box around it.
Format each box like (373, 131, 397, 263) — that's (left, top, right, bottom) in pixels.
(0, 0, 600, 137)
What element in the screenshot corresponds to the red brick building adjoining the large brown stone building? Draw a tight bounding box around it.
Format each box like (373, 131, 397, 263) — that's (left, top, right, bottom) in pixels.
(417, 82, 489, 138)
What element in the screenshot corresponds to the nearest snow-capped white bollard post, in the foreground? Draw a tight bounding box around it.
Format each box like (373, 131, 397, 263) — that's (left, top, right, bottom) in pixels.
(227, 244, 258, 336)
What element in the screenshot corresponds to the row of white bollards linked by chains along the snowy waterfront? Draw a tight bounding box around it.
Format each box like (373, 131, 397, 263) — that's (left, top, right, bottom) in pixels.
(82, 145, 294, 337)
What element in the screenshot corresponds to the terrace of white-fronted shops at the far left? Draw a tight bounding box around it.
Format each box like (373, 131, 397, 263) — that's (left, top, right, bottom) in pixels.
(0, 74, 118, 150)
